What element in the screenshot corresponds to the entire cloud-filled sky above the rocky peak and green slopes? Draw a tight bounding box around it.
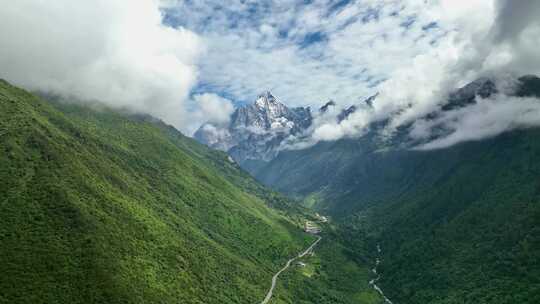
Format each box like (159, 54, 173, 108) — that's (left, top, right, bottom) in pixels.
(0, 0, 540, 146)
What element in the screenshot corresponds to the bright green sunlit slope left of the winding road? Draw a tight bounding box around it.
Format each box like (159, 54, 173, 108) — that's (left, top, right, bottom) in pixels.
(0, 82, 316, 303)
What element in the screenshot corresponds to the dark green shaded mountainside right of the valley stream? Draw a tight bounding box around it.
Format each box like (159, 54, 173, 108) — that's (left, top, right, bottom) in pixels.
(247, 77, 540, 304)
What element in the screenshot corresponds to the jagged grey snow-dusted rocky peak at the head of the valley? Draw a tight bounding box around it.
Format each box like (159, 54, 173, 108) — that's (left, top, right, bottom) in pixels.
(194, 92, 312, 163)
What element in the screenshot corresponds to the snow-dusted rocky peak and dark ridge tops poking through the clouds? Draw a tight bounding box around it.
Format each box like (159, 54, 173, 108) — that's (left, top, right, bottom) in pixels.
(194, 75, 540, 166)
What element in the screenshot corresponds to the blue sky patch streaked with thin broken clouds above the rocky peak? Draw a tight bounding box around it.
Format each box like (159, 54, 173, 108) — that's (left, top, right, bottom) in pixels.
(163, 0, 451, 106)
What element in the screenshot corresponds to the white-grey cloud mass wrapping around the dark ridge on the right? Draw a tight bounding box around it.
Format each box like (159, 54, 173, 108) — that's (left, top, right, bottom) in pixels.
(300, 0, 540, 149)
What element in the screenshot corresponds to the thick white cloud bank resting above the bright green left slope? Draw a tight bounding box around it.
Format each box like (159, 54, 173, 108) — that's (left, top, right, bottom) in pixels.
(0, 0, 204, 129)
